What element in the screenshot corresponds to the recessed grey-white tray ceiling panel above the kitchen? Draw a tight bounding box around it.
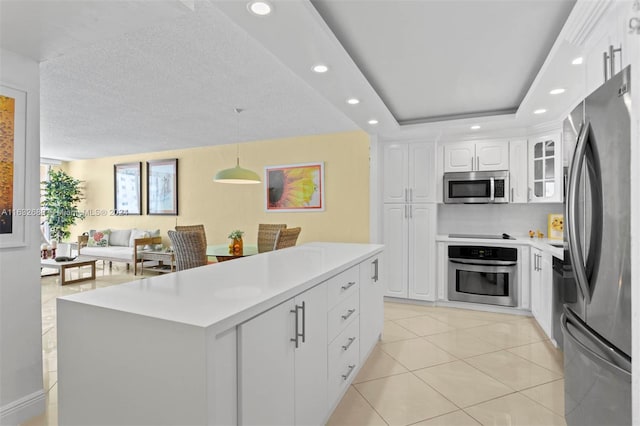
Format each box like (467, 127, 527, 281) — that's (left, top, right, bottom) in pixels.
(312, 0, 575, 124)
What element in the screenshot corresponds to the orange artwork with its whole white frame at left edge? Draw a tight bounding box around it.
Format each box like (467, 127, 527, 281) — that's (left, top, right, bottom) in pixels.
(0, 85, 28, 247)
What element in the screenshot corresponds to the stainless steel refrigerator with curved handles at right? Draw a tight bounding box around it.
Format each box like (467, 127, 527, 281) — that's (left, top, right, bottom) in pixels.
(561, 67, 637, 426)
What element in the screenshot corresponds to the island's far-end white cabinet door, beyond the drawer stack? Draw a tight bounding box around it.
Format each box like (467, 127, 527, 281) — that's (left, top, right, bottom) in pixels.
(360, 254, 384, 363)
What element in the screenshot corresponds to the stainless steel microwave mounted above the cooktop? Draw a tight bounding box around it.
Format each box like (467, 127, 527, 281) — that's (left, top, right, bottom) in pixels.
(443, 170, 509, 204)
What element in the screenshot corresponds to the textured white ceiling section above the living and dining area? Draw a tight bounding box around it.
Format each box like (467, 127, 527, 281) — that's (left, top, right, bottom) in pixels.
(1, 2, 358, 159)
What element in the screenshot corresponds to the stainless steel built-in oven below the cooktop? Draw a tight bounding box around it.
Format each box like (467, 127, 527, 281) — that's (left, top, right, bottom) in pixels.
(447, 245, 518, 306)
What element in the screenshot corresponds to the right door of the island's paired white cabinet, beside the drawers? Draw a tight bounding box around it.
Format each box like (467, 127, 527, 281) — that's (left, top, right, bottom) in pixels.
(294, 283, 328, 425)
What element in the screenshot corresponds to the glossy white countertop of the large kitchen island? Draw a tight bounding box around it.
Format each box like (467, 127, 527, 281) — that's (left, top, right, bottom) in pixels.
(58, 243, 384, 331)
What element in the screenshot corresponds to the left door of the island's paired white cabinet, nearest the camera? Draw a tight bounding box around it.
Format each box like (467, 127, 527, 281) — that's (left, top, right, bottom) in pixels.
(238, 299, 296, 426)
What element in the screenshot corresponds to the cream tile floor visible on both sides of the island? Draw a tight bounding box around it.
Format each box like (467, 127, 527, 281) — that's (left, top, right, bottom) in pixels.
(25, 265, 566, 426)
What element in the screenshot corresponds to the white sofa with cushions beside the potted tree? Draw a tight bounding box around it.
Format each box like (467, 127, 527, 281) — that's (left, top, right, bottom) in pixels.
(78, 228, 162, 275)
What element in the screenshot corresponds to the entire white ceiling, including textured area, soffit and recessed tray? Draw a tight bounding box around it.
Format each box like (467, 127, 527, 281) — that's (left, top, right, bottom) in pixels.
(0, 0, 579, 159)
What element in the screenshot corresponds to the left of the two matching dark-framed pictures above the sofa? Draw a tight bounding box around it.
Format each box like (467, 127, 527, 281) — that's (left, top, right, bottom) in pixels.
(113, 162, 142, 215)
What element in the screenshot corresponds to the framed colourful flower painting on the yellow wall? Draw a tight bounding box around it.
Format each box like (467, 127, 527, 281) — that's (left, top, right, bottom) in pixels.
(264, 163, 324, 212)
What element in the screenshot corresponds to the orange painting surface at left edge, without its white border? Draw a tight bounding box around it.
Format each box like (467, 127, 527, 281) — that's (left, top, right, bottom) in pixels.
(0, 95, 16, 234)
